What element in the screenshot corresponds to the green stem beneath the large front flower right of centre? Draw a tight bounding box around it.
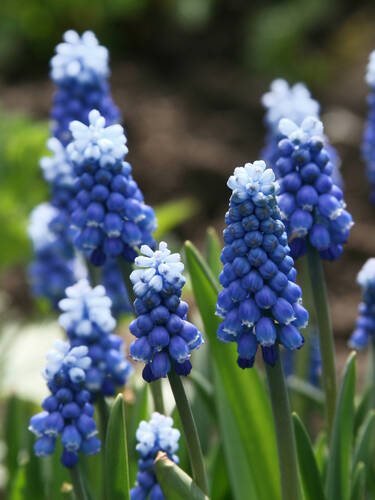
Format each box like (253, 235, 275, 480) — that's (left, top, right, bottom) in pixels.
(265, 352, 300, 500)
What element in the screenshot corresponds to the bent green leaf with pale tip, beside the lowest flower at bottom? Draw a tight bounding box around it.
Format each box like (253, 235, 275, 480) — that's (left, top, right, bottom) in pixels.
(155, 452, 209, 500)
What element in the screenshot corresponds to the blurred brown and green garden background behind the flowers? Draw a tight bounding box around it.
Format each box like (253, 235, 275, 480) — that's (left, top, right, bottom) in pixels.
(0, 0, 375, 382)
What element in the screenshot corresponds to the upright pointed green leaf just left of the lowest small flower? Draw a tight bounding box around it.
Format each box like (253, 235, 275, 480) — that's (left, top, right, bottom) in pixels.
(104, 394, 130, 500)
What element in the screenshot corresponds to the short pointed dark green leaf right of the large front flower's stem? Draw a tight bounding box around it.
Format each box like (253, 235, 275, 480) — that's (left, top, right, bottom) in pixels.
(293, 413, 325, 500)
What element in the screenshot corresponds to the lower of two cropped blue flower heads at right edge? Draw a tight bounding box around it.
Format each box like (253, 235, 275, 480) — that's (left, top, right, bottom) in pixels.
(349, 258, 375, 350)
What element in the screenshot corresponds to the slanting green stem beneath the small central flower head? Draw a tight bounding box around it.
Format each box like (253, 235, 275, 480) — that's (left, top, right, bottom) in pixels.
(168, 370, 208, 495)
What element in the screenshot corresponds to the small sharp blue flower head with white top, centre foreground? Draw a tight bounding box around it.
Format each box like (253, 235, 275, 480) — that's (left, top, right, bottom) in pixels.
(130, 242, 203, 382)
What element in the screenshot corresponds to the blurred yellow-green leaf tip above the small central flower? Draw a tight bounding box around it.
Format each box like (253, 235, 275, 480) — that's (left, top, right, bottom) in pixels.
(154, 198, 199, 240)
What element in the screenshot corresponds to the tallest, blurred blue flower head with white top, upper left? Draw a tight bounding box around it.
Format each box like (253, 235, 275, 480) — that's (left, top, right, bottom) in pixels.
(51, 30, 120, 145)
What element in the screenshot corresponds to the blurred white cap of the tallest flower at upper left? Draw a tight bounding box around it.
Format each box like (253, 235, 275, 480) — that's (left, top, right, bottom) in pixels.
(51, 30, 109, 84)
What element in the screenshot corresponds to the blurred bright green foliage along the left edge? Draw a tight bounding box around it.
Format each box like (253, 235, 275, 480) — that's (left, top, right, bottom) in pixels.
(0, 110, 48, 270)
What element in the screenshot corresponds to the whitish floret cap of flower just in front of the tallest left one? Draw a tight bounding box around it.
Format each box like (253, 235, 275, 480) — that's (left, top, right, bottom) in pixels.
(67, 109, 128, 167)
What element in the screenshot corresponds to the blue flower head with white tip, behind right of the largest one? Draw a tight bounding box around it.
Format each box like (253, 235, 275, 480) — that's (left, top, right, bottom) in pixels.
(275, 116, 353, 260)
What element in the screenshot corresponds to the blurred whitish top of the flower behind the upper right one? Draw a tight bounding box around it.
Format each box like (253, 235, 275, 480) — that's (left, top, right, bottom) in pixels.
(262, 78, 320, 135)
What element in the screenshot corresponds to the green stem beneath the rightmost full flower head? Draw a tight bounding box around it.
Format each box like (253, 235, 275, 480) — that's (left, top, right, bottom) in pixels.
(307, 244, 336, 438)
